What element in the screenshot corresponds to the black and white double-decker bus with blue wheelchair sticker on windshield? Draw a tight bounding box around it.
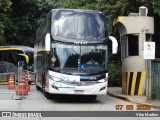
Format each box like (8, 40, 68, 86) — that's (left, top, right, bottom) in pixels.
(34, 9, 118, 99)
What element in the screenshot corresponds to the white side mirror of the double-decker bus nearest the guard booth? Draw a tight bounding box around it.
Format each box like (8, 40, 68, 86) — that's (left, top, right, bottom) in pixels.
(109, 36, 118, 54)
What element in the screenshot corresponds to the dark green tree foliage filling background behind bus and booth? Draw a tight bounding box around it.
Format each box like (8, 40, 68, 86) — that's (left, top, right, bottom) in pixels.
(0, 0, 160, 86)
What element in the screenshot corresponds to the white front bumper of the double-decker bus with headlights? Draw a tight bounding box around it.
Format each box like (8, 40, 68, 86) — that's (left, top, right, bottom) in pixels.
(46, 80, 108, 95)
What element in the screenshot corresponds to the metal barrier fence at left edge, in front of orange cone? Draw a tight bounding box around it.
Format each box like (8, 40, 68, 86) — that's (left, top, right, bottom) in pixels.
(0, 72, 16, 99)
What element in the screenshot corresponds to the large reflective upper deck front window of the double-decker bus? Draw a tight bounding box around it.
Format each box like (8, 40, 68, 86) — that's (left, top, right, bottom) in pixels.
(51, 10, 107, 41)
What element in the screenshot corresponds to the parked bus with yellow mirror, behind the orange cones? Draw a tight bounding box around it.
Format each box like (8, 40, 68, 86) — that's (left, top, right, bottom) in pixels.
(0, 45, 34, 84)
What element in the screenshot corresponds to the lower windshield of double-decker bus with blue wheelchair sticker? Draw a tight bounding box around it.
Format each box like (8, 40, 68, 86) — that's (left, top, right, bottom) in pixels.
(50, 43, 108, 75)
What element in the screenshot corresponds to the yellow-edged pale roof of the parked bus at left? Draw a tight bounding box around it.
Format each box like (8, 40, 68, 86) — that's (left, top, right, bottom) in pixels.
(0, 45, 34, 51)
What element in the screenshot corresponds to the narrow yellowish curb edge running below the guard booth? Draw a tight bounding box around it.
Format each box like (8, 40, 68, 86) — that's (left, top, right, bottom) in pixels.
(107, 92, 160, 109)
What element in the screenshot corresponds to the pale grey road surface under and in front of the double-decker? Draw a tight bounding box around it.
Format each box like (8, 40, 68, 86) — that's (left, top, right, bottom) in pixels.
(0, 85, 139, 111)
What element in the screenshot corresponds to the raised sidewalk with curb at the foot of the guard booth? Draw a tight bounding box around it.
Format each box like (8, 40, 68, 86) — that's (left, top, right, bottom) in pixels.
(107, 87, 160, 109)
